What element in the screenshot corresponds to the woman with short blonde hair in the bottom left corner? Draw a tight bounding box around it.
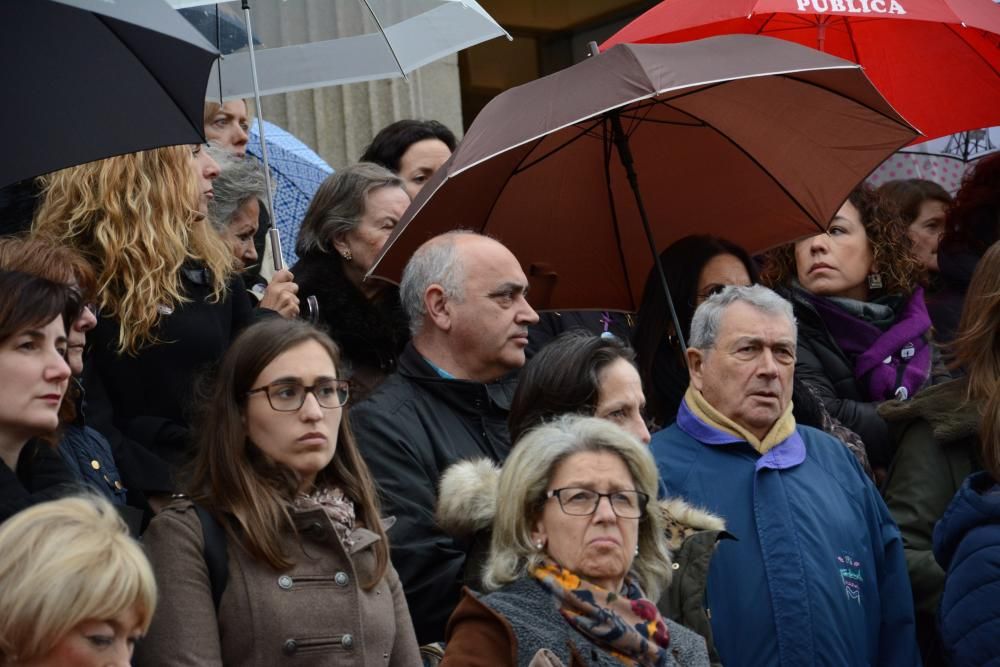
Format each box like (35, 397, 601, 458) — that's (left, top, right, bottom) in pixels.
(0, 496, 156, 667)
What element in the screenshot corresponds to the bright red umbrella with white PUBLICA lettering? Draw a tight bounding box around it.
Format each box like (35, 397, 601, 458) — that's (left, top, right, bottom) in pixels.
(601, 0, 1000, 141)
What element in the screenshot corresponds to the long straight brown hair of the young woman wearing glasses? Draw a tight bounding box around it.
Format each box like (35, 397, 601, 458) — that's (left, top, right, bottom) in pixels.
(189, 317, 389, 590)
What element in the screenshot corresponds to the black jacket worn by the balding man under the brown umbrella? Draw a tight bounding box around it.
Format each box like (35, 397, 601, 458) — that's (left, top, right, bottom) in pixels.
(351, 344, 516, 644)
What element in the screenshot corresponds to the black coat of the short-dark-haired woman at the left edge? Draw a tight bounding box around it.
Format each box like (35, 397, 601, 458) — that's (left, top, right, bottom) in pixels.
(0, 438, 82, 523)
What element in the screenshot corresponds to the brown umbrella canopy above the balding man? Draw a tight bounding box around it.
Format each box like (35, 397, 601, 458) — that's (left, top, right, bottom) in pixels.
(372, 36, 916, 311)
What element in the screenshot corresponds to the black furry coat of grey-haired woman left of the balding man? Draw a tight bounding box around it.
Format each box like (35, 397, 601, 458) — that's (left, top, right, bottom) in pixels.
(292, 252, 410, 403)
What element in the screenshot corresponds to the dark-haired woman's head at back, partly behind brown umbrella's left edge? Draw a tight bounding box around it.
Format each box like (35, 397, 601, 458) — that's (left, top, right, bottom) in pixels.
(359, 119, 456, 199)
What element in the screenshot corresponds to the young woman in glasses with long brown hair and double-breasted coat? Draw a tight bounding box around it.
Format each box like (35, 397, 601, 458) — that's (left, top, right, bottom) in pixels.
(137, 318, 420, 667)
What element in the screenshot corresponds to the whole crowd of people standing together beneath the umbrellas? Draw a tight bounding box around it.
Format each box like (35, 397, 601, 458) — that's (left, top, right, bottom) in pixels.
(0, 95, 1000, 667)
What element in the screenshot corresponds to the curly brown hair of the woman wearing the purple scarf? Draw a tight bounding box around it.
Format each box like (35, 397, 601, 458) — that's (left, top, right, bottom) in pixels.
(761, 184, 923, 294)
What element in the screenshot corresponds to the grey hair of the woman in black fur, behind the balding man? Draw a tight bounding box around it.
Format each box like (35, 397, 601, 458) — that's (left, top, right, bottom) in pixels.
(295, 162, 403, 257)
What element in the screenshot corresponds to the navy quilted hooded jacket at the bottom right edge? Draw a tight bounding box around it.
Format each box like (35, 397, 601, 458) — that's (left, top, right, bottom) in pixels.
(934, 472, 1000, 667)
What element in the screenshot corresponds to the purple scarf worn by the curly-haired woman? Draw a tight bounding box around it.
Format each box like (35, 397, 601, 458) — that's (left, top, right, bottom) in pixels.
(809, 287, 931, 401)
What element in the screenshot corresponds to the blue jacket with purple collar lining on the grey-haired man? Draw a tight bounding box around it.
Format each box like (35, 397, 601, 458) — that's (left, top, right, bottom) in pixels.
(651, 404, 920, 667)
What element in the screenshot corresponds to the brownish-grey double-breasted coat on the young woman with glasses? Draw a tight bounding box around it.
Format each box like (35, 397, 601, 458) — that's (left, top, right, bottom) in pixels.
(134, 499, 420, 667)
